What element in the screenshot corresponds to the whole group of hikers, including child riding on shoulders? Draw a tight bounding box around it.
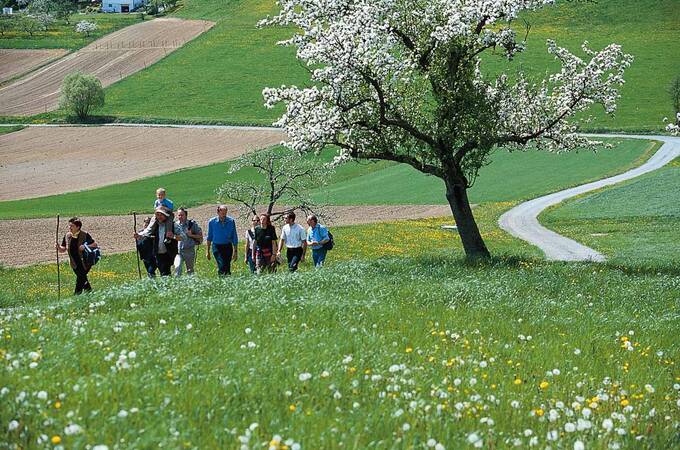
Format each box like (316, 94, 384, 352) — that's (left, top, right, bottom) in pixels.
(56, 188, 333, 295)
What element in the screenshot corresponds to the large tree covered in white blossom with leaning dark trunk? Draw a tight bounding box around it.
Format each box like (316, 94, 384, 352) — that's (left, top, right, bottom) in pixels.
(260, 0, 632, 257)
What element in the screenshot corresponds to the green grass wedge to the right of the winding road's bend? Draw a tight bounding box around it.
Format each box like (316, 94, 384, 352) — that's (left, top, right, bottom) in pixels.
(541, 160, 680, 268)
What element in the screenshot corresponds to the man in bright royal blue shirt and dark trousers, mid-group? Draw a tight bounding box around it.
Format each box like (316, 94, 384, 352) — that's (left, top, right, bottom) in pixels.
(205, 205, 238, 275)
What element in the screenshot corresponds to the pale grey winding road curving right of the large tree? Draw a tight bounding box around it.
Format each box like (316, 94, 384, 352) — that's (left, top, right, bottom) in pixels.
(498, 134, 680, 262)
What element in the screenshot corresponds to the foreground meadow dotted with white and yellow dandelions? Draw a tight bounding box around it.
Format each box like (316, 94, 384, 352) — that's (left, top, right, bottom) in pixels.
(0, 205, 680, 449)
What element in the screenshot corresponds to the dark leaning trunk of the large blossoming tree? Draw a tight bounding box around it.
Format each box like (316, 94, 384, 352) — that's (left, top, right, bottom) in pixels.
(444, 179, 491, 259)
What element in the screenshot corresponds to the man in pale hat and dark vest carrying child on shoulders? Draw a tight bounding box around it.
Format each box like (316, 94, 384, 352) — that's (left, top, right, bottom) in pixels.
(135, 206, 187, 277)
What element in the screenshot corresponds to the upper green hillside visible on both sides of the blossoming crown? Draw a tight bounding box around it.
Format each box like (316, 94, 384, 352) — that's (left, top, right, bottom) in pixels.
(98, 0, 680, 129)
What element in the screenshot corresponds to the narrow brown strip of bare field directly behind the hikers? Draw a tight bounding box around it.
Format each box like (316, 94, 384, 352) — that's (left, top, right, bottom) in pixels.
(0, 205, 453, 266)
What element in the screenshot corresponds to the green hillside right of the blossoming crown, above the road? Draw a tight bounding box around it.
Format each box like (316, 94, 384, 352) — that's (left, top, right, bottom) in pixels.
(494, 0, 680, 130)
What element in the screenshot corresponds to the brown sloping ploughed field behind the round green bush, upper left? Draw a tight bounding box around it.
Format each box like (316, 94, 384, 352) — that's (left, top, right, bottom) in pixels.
(0, 18, 214, 116)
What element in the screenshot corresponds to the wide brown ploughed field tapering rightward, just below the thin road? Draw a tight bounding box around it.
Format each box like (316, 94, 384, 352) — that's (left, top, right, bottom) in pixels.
(0, 126, 285, 201)
